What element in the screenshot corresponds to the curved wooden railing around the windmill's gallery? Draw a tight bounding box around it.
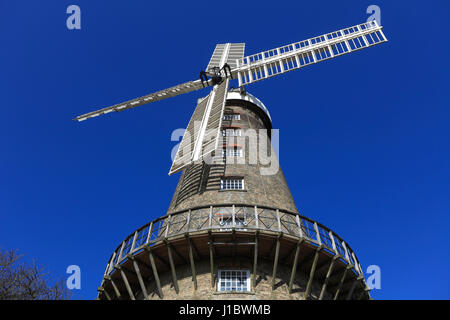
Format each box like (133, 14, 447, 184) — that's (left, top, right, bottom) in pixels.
(101, 205, 363, 276)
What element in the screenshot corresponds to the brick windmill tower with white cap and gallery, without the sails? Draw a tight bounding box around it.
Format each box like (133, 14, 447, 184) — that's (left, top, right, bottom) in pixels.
(98, 92, 370, 300)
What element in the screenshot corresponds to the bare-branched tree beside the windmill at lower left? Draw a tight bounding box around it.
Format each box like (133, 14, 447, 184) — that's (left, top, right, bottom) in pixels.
(0, 249, 71, 300)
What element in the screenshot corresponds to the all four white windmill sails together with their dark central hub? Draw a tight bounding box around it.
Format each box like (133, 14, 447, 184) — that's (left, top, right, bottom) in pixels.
(74, 20, 387, 175)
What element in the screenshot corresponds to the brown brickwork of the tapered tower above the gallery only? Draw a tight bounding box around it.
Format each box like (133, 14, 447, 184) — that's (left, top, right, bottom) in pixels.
(168, 97, 298, 213)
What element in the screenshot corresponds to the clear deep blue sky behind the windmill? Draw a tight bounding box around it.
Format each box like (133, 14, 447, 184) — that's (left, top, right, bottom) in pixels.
(0, 0, 450, 299)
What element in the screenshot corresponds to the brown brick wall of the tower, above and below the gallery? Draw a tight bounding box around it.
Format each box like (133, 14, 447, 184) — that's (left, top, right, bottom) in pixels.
(156, 95, 304, 300)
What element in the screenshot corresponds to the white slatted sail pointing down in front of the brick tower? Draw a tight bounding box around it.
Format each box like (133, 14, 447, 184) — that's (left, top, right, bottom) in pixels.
(169, 79, 229, 175)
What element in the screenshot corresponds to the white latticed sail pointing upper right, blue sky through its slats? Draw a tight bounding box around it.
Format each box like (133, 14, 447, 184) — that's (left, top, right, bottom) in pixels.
(232, 20, 387, 86)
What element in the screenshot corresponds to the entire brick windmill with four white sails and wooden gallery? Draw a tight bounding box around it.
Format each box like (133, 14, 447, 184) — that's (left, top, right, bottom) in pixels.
(76, 21, 387, 300)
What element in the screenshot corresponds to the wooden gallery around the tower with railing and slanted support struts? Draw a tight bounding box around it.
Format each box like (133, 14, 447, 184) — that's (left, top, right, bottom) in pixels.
(98, 204, 370, 300)
